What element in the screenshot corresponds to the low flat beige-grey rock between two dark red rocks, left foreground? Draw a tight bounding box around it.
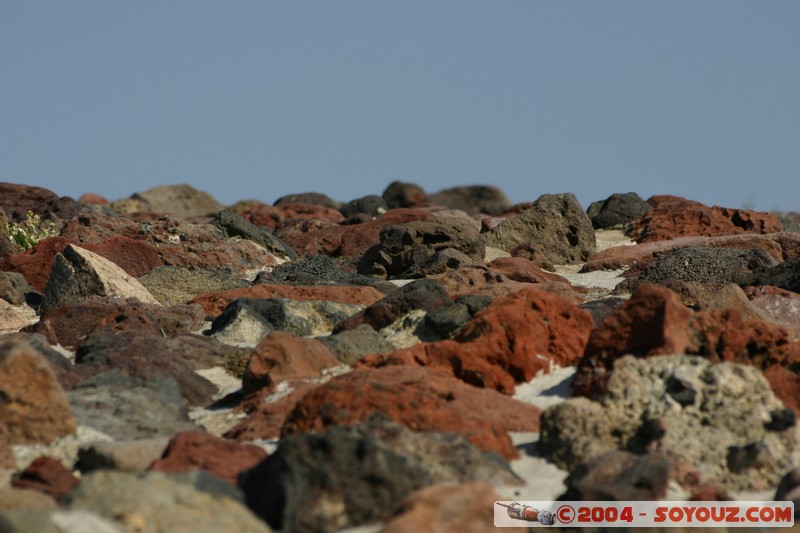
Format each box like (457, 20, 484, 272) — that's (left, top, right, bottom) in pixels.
(77, 437, 170, 473)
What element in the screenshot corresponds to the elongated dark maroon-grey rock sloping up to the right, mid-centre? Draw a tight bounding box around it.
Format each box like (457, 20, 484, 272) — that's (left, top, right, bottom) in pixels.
(333, 279, 450, 333)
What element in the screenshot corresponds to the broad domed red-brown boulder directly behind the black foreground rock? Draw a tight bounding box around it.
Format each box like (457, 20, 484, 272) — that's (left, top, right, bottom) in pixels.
(282, 366, 541, 459)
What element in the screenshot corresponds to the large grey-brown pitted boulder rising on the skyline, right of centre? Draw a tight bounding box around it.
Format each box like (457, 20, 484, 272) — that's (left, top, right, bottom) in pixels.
(483, 193, 597, 264)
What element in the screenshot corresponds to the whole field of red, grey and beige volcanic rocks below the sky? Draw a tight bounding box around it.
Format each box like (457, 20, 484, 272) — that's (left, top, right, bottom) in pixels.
(0, 182, 800, 533)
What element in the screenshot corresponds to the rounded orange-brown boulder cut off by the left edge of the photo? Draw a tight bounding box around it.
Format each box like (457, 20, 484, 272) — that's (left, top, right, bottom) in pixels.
(0, 339, 75, 444)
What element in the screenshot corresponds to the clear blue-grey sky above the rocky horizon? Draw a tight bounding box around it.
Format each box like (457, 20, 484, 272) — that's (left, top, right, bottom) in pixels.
(0, 0, 800, 211)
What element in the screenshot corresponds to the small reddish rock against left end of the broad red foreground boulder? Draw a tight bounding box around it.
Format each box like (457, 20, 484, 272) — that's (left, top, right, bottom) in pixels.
(223, 381, 317, 442)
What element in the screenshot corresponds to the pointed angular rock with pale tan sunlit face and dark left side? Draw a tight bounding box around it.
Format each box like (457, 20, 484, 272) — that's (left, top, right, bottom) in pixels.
(42, 244, 158, 315)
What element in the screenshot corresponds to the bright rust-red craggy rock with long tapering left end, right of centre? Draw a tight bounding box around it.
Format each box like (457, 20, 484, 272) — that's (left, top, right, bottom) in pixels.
(359, 288, 593, 394)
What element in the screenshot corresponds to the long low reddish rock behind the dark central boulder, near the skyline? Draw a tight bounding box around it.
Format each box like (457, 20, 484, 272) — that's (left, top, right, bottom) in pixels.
(275, 209, 435, 257)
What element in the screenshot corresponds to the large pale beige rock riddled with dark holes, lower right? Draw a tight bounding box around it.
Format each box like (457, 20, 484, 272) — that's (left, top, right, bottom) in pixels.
(539, 355, 797, 490)
